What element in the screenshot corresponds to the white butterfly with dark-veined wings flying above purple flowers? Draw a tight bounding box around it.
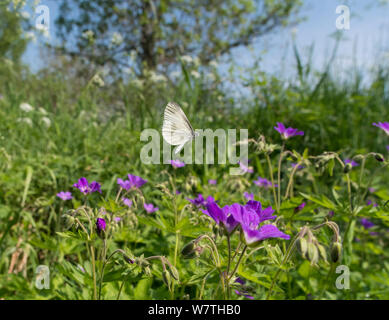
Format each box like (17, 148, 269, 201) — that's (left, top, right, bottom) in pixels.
(162, 102, 199, 154)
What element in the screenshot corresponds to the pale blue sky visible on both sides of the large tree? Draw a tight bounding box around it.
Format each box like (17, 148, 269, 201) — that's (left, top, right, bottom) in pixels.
(23, 0, 389, 74)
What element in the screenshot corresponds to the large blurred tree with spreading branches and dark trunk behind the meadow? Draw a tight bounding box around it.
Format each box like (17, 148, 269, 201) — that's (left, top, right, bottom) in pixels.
(56, 0, 301, 74)
